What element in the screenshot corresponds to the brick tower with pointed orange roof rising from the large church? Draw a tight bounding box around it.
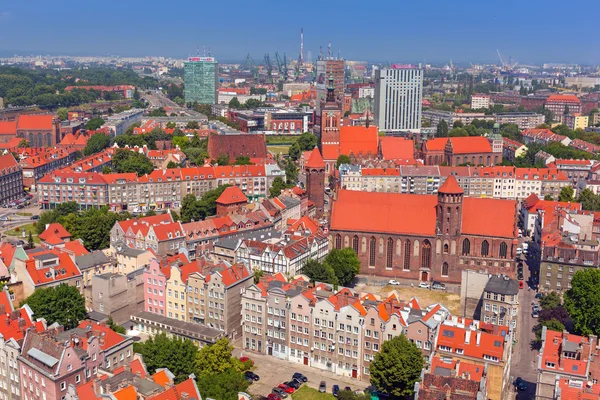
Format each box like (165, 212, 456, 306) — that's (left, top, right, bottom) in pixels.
(437, 175, 465, 237)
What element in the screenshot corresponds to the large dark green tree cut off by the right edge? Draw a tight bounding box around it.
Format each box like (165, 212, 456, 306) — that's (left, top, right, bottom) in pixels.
(565, 268, 600, 335)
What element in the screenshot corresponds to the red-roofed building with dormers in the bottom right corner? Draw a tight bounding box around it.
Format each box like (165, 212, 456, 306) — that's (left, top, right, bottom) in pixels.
(535, 326, 600, 400)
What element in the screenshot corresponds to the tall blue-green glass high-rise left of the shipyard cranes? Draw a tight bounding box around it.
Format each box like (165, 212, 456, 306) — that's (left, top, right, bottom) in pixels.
(183, 57, 219, 104)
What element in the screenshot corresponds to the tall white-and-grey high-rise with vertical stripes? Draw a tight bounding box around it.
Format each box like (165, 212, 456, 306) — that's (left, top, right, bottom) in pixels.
(374, 64, 423, 133)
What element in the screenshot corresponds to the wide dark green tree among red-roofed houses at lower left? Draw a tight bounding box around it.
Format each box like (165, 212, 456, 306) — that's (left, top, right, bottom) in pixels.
(21, 283, 86, 330)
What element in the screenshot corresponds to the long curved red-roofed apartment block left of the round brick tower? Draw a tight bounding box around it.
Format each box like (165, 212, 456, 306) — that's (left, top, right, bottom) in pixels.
(38, 164, 285, 212)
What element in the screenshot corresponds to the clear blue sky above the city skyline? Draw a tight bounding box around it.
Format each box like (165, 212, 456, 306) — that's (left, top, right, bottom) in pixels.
(0, 0, 600, 64)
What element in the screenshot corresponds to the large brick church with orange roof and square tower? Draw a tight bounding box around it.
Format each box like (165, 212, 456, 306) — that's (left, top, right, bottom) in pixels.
(329, 175, 517, 283)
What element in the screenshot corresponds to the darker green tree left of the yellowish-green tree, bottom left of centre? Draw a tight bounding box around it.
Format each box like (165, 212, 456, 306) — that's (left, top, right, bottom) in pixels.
(134, 333, 198, 383)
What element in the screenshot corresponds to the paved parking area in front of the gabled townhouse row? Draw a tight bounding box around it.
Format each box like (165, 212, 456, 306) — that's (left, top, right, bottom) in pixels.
(233, 346, 370, 396)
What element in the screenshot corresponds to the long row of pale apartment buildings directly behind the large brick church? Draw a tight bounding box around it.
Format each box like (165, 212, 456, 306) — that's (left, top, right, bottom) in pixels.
(339, 164, 571, 199)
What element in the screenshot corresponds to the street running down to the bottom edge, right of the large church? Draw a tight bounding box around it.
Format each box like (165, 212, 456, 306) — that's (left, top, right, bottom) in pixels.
(511, 248, 538, 399)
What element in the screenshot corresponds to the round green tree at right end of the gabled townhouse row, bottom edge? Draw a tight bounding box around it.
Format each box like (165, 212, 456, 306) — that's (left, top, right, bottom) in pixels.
(370, 335, 423, 398)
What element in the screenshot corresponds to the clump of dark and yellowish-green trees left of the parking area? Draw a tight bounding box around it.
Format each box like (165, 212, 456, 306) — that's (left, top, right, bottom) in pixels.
(134, 334, 251, 400)
